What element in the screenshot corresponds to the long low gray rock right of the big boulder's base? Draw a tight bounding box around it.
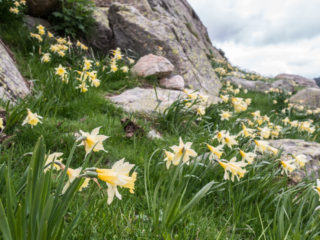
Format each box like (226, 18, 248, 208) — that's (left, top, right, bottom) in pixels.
(225, 77, 295, 92)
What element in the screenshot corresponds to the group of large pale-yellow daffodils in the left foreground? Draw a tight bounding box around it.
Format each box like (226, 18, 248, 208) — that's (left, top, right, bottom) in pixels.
(44, 127, 137, 204)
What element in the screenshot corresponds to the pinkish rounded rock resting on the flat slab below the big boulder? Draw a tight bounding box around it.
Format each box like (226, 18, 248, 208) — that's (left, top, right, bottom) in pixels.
(131, 54, 174, 78)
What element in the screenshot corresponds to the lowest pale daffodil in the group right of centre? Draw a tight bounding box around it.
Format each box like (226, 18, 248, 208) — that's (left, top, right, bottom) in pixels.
(218, 157, 248, 182)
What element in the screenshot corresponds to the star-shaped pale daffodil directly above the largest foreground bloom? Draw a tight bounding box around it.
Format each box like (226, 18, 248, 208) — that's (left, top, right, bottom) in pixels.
(78, 127, 109, 155)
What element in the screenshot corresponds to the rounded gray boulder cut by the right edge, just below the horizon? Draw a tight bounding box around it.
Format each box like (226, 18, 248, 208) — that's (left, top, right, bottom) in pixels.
(290, 88, 320, 109)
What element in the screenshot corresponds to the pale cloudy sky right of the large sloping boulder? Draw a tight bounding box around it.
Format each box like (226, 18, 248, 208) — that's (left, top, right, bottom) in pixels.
(188, 0, 320, 78)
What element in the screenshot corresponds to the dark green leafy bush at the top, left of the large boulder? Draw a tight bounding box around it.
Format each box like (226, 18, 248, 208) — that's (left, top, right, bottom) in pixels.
(50, 0, 95, 38)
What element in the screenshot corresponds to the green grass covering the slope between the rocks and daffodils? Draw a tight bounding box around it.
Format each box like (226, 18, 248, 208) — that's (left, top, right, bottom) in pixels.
(0, 14, 320, 240)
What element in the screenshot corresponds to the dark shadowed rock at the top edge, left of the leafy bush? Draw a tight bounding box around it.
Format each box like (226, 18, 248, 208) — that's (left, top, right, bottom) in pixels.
(27, 0, 59, 17)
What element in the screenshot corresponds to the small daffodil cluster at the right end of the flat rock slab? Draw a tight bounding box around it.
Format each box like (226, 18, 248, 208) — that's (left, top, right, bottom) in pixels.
(183, 89, 208, 119)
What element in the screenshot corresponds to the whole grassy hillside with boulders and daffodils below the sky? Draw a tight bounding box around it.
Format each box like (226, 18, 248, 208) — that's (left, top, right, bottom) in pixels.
(0, 0, 320, 240)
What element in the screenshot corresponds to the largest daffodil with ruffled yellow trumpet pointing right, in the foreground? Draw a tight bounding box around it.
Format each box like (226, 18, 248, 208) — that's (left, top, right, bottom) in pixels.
(96, 159, 137, 204)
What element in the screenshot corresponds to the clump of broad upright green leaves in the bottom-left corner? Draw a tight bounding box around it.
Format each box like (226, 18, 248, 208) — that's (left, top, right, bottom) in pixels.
(0, 137, 87, 240)
